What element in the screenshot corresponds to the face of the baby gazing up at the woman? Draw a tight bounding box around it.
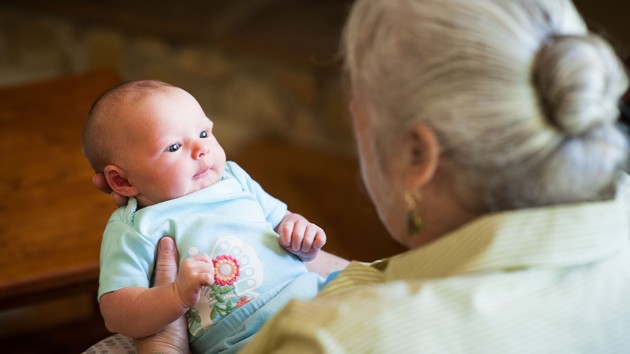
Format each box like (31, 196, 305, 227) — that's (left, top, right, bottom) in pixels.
(120, 88, 226, 206)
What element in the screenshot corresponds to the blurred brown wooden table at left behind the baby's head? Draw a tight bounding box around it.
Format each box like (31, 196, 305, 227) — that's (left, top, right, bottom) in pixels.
(0, 72, 119, 309)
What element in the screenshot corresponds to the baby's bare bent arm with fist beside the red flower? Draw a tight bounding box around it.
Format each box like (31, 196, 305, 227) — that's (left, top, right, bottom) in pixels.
(100, 254, 214, 338)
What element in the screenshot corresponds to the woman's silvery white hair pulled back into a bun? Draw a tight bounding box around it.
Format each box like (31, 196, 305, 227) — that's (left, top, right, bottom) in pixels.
(343, 0, 628, 210)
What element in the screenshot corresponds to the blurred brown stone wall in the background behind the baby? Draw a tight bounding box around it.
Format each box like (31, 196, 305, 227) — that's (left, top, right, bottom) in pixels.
(0, 5, 354, 155)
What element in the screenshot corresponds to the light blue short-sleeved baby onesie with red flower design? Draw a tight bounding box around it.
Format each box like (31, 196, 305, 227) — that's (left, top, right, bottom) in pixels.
(98, 162, 322, 353)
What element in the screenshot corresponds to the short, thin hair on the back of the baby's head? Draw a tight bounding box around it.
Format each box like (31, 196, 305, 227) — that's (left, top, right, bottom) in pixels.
(83, 80, 174, 172)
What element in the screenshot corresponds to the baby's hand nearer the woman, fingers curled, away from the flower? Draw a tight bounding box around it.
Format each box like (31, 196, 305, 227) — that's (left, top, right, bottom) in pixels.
(278, 213, 326, 262)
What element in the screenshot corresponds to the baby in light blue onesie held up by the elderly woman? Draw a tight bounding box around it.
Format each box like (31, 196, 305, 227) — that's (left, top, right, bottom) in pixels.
(83, 80, 326, 352)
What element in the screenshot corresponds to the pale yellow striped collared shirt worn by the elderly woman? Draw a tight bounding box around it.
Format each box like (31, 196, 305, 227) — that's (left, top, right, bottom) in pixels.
(244, 177, 630, 353)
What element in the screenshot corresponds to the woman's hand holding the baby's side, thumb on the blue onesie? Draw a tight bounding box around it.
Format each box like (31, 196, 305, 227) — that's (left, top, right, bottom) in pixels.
(135, 235, 190, 354)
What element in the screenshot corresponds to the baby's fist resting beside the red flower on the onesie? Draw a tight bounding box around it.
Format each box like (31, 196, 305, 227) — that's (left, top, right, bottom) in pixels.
(175, 254, 214, 308)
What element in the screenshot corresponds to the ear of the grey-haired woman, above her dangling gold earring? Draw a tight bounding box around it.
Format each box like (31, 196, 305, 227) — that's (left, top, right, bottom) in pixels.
(409, 124, 440, 190)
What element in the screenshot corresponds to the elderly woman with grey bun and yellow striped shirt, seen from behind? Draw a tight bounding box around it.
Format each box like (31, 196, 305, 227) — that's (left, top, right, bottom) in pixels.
(87, 0, 630, 353)
